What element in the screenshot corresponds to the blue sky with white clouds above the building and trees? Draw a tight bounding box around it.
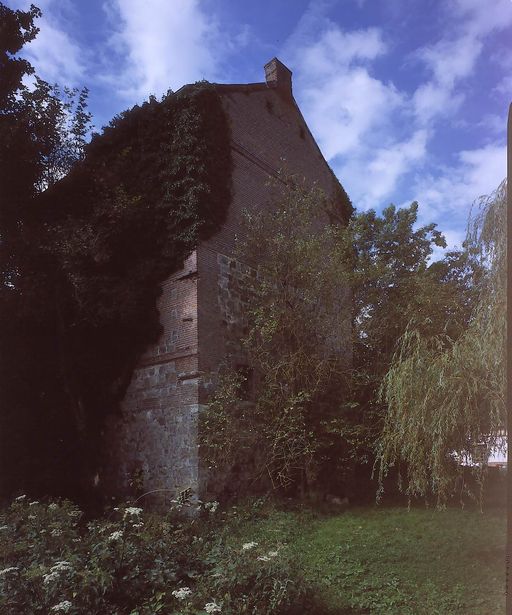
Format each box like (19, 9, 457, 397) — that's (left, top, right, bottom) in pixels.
(6, 0, 512, 253)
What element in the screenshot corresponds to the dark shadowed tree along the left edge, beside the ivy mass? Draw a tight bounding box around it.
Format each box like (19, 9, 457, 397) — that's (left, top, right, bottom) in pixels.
(0, 3, 91, 500)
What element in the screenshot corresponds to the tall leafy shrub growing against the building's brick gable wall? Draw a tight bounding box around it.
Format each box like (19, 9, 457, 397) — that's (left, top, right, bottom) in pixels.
(202, 178, 351, 496)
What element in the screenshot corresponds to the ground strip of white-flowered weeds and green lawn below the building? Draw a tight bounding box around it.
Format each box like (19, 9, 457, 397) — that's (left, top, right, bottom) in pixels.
(0, 496, 505, 615)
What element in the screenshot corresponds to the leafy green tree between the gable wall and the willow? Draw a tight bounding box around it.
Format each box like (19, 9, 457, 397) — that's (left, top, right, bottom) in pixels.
(344, 203, 479, 491)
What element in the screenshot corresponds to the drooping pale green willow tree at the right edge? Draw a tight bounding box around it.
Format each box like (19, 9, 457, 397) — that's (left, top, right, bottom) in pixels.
(376, 182, 506, 505)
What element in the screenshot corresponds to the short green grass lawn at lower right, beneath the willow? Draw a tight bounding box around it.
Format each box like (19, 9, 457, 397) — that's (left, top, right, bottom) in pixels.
(222, 508, 506, 615)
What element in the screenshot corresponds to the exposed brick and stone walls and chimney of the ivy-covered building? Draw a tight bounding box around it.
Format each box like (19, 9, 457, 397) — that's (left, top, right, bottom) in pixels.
(106, 58, 350, 502)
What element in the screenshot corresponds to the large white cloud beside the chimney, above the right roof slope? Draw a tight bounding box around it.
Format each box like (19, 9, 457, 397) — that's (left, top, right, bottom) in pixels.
(287, 16, 428, 209)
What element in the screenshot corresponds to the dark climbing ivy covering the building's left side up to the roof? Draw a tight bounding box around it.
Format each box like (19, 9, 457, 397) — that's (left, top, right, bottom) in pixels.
(4, 82, 231, 495)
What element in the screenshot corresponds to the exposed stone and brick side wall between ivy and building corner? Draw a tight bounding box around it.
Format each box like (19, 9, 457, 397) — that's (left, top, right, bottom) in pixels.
(106, 253, 198, 503)
